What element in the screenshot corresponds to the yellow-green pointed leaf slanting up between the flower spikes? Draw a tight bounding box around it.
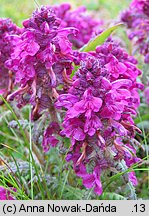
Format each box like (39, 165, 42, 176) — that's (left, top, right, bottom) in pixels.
(80, 23, 123, 52)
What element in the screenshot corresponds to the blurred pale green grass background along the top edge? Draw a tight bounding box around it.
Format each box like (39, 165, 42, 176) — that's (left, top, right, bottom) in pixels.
(0, 0, 130, 26)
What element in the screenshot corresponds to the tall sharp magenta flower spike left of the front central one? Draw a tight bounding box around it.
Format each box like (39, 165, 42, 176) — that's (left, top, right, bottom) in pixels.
(6, 6, 77, 119)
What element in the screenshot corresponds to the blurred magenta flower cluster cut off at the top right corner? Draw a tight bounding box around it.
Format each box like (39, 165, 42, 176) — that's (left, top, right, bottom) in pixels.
(121, 0, 149, 63)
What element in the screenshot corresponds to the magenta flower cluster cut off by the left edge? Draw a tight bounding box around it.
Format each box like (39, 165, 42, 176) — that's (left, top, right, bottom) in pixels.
(0, 19, 21, 103)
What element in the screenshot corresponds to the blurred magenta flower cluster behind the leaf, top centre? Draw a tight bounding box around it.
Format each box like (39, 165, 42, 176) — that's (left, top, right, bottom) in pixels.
(53, 3, 103, 48)
